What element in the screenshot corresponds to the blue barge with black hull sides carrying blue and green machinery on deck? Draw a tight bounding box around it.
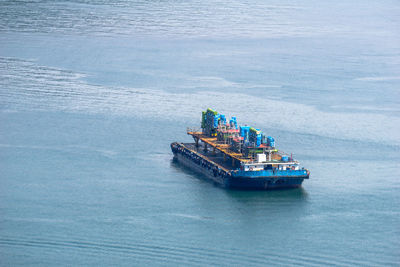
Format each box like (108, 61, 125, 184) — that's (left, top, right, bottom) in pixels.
(171, 109, 310, 190)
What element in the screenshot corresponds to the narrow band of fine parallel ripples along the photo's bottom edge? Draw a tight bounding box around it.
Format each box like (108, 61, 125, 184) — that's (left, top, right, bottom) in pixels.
(0, 238, 396, 266)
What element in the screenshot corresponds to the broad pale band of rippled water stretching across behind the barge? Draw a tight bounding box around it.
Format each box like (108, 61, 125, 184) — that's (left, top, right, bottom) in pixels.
(0, 58, 400, 149)
